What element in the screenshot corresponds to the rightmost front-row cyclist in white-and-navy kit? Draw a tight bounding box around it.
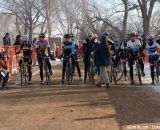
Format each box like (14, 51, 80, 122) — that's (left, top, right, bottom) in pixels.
(146, 35, 160, 85)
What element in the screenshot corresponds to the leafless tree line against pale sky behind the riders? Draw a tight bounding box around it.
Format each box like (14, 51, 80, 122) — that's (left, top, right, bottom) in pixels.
(0, 0, 160, 40)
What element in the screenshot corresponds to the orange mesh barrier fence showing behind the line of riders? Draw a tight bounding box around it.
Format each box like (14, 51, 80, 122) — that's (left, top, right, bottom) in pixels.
(0, 46, 160, 74)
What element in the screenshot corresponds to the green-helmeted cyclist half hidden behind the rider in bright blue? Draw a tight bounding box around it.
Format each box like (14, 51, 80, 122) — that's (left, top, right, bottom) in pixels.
(70, 33, 82, 80)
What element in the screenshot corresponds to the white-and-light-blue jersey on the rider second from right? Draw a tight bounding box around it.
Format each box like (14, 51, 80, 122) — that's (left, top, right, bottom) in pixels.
(127, 39, 141, 53)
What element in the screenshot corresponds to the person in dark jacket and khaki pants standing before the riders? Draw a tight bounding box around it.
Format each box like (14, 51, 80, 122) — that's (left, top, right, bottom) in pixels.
(95, 32, 111, 87)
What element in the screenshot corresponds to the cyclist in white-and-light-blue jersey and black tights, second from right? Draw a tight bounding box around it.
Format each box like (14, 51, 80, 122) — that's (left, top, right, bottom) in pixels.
(127, 31, 145, 84)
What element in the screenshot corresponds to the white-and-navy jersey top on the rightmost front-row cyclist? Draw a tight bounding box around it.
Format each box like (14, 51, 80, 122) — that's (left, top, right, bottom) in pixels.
(146, 42, 160, 56)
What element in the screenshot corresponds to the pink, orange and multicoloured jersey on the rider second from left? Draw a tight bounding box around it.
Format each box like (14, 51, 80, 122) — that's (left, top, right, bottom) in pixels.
(35, 40, 50, 55)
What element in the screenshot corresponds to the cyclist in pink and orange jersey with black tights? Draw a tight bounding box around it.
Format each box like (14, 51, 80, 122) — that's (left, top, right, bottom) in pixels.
(35, 32, 54, 84)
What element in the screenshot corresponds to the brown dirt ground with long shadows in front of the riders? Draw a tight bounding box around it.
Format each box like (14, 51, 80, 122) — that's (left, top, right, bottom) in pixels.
(0, 66, 160, 130)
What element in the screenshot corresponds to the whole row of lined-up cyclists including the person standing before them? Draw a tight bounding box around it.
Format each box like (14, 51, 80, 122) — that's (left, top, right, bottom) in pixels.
(0, 31, 160, 89)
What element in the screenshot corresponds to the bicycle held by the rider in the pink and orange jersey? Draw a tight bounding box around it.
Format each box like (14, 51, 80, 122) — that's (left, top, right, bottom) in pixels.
(42, 56, 51, 85)
